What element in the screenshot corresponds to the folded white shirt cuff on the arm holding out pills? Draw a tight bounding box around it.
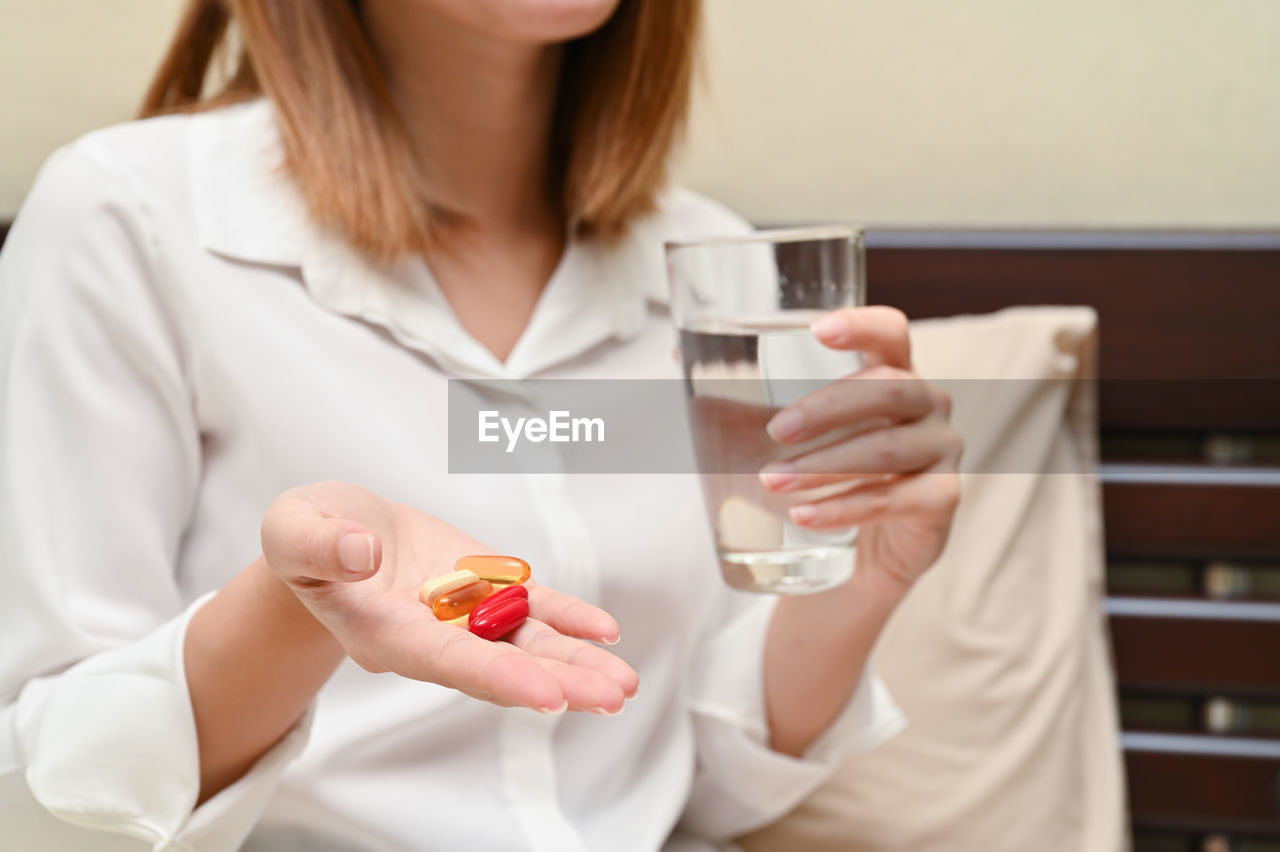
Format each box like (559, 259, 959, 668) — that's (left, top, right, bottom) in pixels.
(19, 594, 314, 849)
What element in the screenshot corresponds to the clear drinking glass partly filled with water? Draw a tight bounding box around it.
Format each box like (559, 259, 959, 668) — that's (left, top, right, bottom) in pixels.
(666, 226, 865, 595)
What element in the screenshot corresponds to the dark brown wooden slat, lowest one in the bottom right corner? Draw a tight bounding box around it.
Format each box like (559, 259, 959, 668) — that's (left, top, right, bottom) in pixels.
(1125, 751, 1280, 837)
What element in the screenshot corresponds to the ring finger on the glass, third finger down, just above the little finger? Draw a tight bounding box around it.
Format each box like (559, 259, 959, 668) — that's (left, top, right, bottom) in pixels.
(760, 413, 961, 493)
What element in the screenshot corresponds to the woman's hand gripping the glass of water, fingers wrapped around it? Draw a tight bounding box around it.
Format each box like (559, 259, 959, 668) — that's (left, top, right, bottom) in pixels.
(760, 307, 964, 592)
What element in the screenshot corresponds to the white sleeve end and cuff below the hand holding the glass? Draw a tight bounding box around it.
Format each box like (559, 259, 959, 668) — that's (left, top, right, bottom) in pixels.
(681, 583, 905, 840)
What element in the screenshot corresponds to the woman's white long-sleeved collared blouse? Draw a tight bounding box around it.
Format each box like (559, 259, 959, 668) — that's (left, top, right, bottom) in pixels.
(0, 101, 902, 852)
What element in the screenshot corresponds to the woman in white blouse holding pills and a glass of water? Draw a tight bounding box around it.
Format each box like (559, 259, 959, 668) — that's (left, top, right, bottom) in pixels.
(0, 0, 959, 849)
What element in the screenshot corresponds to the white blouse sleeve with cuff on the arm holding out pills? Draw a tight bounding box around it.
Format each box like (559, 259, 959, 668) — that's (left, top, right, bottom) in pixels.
(0, 142, 310, 851)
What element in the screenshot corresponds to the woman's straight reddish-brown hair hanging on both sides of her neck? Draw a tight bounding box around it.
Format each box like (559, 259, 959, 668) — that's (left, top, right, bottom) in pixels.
(142, 0, 700, 261)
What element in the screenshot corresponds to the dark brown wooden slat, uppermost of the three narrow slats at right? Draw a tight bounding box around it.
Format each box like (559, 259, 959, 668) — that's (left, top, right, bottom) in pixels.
(1102, 481, 1280, 560)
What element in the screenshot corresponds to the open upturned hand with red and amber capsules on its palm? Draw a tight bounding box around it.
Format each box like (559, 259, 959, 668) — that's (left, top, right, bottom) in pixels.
(262, 482, 637, 714)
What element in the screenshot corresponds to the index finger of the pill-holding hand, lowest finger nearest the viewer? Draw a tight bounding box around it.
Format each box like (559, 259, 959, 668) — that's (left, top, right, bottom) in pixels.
(373, 620, 568, 713)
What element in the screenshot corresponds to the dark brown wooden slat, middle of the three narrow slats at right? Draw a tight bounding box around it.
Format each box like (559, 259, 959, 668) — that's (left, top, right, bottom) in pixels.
(1111, 615, 1280, 697)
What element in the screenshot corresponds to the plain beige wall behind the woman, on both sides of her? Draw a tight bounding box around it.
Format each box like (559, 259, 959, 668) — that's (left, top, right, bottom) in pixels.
(0, 0, 1280, 228)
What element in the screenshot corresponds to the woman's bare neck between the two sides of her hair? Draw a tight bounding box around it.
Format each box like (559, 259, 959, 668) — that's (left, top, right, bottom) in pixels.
(364, 1, 563, 234)
